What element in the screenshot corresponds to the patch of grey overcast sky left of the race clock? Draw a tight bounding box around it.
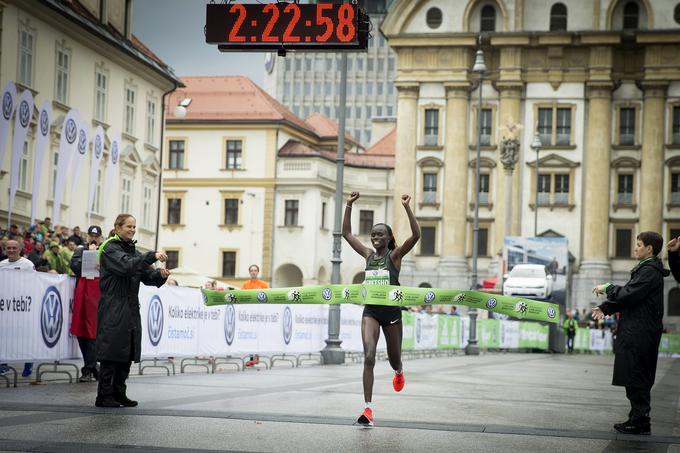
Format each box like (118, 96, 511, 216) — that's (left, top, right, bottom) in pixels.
(132, 0, 264, 86)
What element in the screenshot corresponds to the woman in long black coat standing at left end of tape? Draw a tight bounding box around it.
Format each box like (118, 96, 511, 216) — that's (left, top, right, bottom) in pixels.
(95, 214, 170, 407)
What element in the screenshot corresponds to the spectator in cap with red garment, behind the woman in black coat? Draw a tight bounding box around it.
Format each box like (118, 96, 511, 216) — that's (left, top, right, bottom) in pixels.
(69, 225, 102, 382)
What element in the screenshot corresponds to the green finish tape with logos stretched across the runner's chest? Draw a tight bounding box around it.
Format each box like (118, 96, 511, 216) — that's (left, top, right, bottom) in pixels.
(201, 284, 559, 323)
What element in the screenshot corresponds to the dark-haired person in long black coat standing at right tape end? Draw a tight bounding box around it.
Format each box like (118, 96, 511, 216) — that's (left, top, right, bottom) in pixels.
(593, 231, 670, 435)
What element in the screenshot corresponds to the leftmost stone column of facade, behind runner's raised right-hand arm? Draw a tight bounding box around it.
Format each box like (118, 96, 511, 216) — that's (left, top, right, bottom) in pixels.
(392, 84, 419, 285)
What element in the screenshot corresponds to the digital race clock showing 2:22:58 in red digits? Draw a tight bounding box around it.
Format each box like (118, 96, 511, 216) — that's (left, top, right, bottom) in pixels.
(205, 2, 369, 51)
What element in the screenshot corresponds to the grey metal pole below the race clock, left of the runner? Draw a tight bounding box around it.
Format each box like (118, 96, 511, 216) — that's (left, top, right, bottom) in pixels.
(321, 53, 347, 364)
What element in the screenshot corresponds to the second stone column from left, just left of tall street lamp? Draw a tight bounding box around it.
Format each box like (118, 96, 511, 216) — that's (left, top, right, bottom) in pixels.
(438, 82, 470, 288)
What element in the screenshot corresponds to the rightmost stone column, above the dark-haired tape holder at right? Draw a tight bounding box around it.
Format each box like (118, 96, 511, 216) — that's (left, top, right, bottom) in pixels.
(640, 82, 667, 235)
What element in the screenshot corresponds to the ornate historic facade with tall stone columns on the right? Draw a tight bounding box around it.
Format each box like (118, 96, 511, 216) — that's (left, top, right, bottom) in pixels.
(381, 0, 680, 328)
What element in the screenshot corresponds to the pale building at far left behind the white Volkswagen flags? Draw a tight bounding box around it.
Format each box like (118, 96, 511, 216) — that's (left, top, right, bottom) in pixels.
(0, 0, 180, 249)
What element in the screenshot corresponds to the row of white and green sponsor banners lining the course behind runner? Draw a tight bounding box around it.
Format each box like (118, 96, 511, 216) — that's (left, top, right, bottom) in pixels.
(0, 270, 680, 362)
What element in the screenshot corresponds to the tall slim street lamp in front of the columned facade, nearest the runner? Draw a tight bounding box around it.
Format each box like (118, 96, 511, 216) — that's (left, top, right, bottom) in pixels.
(465, 46, 486, 355)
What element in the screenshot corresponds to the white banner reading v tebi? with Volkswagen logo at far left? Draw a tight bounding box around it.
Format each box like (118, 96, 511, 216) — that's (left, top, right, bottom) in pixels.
(0, 269, 78, 362)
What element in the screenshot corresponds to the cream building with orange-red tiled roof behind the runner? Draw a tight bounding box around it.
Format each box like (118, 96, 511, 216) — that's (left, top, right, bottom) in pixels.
(160, 77, 393, 287)
